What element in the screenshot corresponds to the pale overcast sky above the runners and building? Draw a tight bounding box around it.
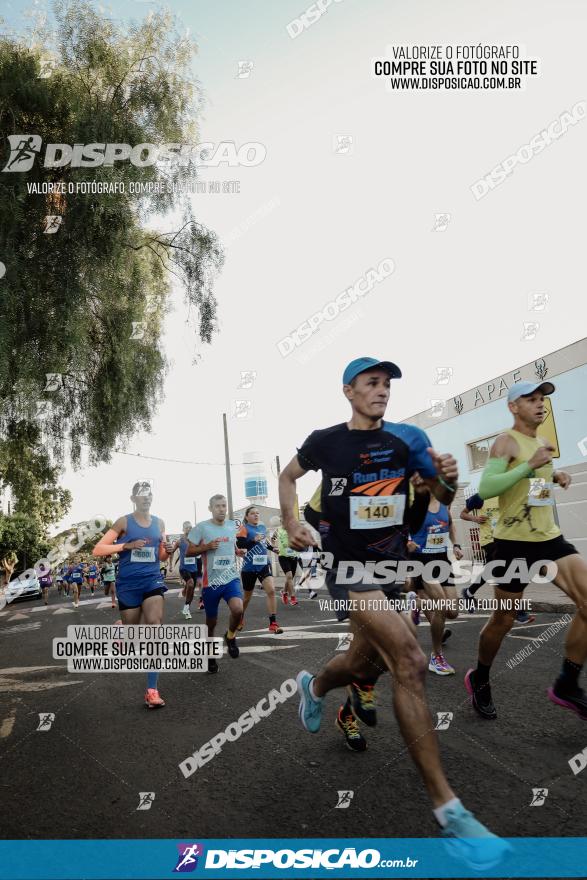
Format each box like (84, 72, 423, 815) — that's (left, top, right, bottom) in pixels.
(4, 0, 587, 531)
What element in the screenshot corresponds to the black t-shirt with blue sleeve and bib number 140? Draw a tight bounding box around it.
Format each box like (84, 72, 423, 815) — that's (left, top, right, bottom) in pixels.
(298, 422, 436, 562)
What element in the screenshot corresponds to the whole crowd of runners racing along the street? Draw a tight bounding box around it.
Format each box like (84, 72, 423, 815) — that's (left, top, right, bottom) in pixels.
(14, 358, 587, 868)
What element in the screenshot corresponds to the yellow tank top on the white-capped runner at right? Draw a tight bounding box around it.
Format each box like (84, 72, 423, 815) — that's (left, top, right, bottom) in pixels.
(494, 428, 561, 542)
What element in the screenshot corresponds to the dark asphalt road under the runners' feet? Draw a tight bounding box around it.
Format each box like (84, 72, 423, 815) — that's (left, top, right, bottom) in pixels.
(0, 584, 587, 839)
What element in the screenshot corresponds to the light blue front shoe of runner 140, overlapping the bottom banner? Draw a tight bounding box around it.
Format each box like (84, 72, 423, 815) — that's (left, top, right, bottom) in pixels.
(441, 803, 511, 871)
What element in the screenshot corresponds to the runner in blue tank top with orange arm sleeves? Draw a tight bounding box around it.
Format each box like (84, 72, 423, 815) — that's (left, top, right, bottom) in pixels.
(93, 482, 172, 709)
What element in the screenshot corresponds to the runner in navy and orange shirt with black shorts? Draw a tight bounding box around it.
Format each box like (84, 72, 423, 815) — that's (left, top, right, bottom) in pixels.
(236, 504, 283, 634)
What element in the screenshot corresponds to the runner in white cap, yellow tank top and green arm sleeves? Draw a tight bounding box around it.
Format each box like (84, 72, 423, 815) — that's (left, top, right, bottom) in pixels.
(465, 382, 587, 719)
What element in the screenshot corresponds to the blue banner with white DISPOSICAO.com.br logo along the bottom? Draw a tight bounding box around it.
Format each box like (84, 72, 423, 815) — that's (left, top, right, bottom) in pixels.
(0, 837, 587, 880)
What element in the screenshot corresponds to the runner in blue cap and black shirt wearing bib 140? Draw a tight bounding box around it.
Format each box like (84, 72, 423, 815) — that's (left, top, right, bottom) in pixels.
(279, 357, 506, 866)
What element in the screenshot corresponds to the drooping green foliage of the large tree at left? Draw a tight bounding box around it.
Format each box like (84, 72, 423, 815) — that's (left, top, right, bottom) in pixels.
(0, 0, 222, 502)
